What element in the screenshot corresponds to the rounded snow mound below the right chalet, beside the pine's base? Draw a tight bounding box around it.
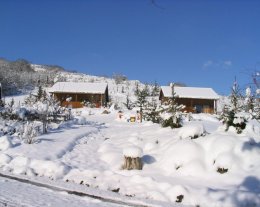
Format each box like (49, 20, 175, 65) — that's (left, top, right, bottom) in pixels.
(178, 123, 205, 139)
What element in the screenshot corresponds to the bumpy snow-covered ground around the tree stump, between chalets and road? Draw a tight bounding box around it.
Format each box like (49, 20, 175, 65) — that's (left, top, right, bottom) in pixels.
(0, 104, 260, 206)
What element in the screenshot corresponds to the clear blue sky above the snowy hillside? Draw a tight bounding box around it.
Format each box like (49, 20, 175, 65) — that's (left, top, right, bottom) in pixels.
(0, 0, 260, 95)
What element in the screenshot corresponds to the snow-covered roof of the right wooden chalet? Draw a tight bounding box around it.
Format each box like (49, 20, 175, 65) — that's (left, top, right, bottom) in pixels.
(161, 86, 219, 99)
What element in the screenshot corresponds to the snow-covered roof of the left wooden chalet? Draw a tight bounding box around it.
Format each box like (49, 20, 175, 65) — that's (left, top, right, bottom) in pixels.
(49, 82, 107, 94)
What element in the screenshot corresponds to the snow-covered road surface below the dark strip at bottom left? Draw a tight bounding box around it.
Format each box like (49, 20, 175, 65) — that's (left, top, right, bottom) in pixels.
(0, 177, 124, 207)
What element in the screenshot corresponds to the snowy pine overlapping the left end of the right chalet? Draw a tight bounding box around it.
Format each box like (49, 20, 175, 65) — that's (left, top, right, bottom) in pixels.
(161, 83, 185, 128)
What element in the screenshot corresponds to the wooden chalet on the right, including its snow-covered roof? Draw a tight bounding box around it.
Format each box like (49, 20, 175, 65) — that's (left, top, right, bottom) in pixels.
(159, 86, 219, 114)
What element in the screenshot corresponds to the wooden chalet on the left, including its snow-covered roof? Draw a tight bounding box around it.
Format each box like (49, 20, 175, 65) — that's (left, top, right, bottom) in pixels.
(49, 82, 108, 108)
